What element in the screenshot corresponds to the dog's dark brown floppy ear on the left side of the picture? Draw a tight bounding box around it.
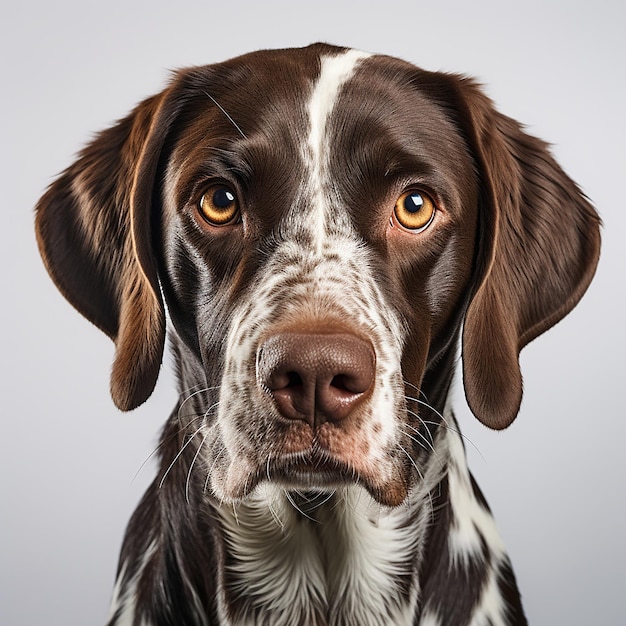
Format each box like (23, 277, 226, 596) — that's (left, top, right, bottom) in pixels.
(36, 91, 180, 411)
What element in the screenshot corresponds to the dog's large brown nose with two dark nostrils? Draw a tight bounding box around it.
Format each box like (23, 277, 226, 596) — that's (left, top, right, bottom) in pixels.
(257, 332, 376, 427)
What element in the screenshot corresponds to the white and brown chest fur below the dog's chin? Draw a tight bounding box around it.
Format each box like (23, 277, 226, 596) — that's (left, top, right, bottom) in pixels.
(220, 485, 424, 626)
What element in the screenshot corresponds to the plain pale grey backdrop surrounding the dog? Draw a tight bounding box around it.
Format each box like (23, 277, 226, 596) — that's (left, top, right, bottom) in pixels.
(0, 0, 626, 626)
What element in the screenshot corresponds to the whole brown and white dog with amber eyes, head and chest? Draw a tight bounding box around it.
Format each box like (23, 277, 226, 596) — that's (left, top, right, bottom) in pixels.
(36, 44, 600, 626)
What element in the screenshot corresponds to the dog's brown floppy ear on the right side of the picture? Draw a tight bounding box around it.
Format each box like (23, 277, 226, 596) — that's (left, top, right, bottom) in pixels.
(459, 81, 600, 429)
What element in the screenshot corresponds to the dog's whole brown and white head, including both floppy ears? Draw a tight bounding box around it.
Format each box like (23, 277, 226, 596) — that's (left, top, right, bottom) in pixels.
(37, 45, 599, 505)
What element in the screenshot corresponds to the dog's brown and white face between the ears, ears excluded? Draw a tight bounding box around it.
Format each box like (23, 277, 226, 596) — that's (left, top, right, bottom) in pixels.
(160, 47, 478, 502)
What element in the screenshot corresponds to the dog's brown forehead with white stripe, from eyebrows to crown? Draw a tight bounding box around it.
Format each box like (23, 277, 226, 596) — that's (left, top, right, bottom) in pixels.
(165, 45, 473, 225)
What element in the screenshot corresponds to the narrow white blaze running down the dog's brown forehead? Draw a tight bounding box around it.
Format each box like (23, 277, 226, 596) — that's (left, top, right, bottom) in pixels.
(305, 50, 370, 246)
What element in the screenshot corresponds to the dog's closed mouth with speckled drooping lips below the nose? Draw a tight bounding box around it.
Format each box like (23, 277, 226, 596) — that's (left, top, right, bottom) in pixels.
(209, 400, 421, 507)
